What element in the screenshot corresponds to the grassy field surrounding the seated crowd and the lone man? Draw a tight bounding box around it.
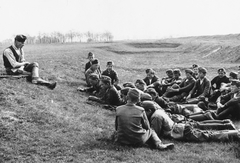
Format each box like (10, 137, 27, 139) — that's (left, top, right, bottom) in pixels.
(0, 36, 240, 163)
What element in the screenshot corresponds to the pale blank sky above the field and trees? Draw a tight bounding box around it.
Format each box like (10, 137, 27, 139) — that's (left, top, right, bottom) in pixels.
(0, 0, 240, 41)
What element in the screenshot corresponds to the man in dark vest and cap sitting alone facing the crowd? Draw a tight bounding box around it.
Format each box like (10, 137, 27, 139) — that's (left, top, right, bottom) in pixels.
(3, 35, 57, 89)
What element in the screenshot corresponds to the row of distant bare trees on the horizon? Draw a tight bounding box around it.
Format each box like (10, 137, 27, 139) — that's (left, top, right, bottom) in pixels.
(2, 30, 113, 44)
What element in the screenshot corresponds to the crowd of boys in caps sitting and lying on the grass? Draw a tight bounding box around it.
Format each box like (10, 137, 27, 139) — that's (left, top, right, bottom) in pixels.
(81, 53, 240, 150)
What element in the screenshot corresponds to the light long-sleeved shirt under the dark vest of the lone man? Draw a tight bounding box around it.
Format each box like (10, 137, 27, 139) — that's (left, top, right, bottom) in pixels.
(3, 44, 25, 72)
